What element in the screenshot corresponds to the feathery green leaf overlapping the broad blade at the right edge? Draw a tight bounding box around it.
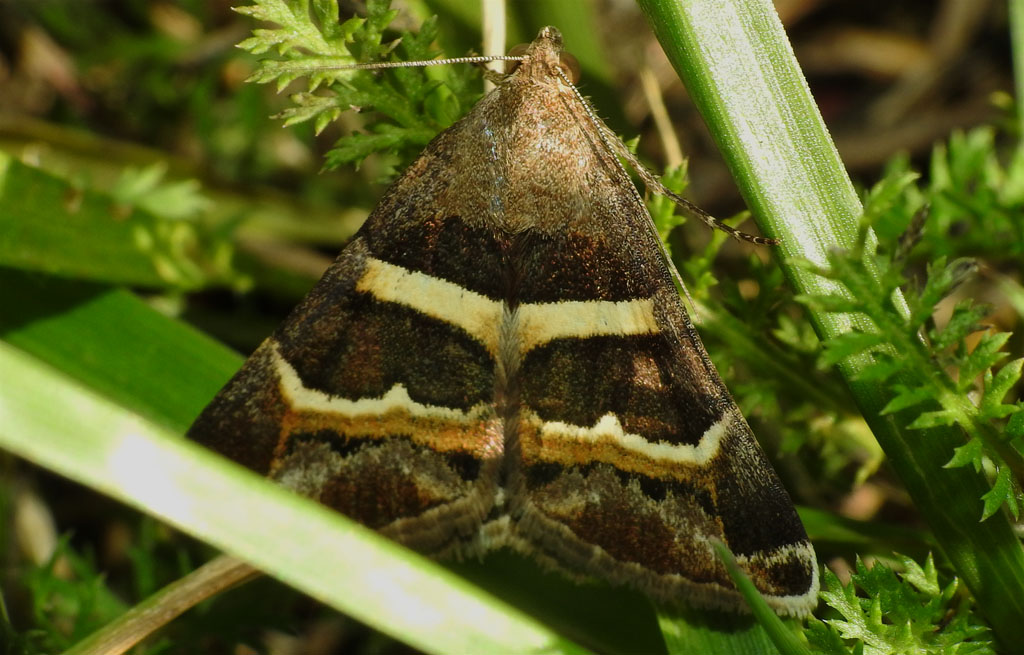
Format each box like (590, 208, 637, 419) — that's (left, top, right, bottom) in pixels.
(798, 157, 1024, 517)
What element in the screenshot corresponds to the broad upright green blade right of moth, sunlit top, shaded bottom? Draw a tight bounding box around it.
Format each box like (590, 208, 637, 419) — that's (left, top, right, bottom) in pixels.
(639, 0, 1024, 645)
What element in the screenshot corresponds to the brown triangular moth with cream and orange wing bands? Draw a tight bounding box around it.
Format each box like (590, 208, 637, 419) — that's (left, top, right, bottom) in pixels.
(188, 28, 818, 615)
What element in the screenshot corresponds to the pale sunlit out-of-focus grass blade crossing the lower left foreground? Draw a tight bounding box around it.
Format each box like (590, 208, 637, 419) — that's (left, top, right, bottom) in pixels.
(0, 342, 582, 653)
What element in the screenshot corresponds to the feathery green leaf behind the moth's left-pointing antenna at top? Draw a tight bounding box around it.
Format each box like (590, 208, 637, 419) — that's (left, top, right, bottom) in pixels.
(239, 0, 479, 169)
